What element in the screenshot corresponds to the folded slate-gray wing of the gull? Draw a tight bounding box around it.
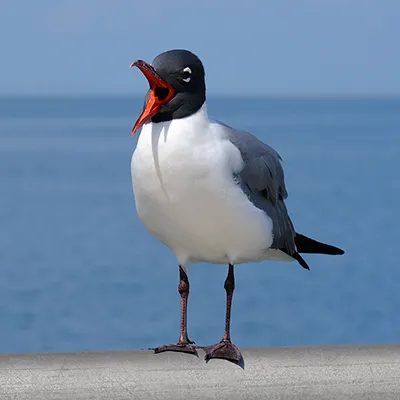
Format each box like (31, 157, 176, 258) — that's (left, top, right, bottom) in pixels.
(224, 125, 296, 255)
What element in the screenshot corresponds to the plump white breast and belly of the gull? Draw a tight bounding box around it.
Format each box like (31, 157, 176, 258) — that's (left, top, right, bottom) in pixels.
(132, 105, 272, 265)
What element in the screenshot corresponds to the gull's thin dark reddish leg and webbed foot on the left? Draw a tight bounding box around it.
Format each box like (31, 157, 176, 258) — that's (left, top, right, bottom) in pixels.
(151, 266, 197, 355)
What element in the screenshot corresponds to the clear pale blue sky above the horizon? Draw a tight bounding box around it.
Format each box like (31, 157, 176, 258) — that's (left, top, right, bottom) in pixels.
(0, 0, 400, 96)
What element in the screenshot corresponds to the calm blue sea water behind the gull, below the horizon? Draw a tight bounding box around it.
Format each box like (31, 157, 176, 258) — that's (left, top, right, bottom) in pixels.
(0, 98, 400, 353)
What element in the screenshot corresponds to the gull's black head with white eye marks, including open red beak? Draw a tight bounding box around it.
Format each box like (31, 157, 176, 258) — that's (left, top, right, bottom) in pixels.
(131, 50, 206, 133)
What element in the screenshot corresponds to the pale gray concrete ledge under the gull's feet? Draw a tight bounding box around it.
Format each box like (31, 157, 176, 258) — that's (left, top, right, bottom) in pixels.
(0, 345, 400, 400)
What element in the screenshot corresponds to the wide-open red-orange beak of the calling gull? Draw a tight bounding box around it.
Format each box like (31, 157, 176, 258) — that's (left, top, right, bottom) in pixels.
(130, 60, 175, 136)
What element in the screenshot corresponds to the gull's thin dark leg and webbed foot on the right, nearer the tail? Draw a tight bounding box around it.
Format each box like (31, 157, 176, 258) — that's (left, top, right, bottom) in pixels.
(204, 264, 243, 364)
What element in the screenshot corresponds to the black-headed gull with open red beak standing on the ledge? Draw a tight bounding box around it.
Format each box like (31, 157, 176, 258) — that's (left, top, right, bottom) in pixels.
(130, 49, 344, 364)
